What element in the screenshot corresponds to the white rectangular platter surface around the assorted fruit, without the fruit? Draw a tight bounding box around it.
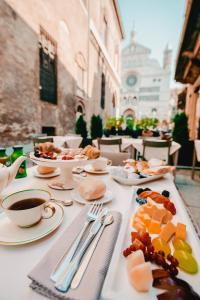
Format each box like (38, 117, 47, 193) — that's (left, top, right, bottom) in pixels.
(102, 186, 200, 300)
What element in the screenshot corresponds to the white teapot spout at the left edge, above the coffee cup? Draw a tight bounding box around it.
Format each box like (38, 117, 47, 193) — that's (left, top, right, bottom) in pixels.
(0, 156, 27, 193)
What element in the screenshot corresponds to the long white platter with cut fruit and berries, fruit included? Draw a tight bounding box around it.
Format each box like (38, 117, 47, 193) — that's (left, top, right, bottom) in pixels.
(103, 188, 200, 300)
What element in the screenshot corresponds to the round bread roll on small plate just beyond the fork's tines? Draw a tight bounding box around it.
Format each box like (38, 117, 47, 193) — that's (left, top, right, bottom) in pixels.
(78, 178, 106, 201)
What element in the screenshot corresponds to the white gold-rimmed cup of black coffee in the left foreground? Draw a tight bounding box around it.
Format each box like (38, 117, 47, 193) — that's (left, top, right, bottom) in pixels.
(1, 189, 55, 227)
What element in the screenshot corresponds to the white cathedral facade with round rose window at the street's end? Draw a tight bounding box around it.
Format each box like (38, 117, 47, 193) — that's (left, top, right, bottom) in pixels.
(119, 31, 172, 120)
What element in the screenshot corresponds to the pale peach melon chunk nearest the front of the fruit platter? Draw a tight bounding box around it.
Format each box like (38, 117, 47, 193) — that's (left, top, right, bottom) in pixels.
(128, 262, 153, 292)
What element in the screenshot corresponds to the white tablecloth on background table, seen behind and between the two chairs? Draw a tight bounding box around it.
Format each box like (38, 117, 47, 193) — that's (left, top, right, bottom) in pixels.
(93, 136, 181, 159)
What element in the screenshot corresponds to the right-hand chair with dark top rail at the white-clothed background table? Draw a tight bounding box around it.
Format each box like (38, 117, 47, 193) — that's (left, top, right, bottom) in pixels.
(142, 140, 172, 164)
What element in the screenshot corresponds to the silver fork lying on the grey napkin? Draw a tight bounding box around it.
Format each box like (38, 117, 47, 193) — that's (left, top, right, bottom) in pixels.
(50, 203, 102, 282)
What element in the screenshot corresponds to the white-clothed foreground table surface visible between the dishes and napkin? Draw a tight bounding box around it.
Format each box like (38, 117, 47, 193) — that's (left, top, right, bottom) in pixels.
(0, 166, 197, 300)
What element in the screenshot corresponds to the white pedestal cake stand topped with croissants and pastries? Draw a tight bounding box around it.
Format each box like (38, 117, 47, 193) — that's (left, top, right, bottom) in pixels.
(30, 142, 100, 190)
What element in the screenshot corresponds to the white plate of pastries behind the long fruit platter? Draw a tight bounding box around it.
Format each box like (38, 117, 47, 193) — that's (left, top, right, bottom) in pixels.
(110, 159, 174, 185)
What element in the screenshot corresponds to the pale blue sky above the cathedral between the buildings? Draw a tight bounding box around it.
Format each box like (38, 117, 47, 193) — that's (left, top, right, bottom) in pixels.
(118, 0, 186, 87)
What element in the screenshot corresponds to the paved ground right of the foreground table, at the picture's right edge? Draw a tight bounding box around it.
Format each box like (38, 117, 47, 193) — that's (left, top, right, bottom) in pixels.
(175, 170, 200, 235)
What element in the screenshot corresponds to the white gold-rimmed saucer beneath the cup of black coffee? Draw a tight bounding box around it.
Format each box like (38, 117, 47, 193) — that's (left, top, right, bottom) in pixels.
(0, 203, 64, 246)
